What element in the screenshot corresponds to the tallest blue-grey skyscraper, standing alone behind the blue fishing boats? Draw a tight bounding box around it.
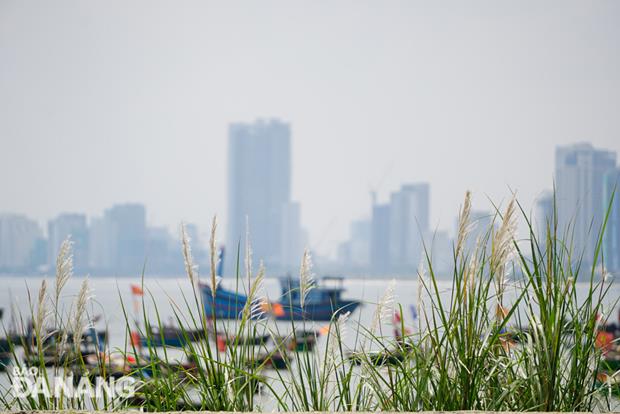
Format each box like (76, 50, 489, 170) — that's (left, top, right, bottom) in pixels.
(224, 119, 298, 274)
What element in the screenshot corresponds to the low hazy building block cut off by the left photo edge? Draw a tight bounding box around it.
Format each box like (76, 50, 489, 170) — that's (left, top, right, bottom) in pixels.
(0, 214, 41, 272)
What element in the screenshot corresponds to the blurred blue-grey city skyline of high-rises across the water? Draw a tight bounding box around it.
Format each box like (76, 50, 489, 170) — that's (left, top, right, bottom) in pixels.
(0, 139, 620, 276)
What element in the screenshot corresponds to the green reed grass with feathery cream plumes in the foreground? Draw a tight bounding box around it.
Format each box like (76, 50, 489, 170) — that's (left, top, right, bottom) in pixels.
(0, 192, 620, 411)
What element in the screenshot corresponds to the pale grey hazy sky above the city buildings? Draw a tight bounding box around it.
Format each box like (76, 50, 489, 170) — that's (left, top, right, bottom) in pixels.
(0, 0, 620, 258)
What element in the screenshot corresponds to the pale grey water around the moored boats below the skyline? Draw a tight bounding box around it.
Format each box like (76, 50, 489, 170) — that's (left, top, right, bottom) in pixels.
(0, 276, 620, 349)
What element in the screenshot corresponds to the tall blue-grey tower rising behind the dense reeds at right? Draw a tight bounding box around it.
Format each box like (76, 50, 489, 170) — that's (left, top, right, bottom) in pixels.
(555, 143, 616, 264)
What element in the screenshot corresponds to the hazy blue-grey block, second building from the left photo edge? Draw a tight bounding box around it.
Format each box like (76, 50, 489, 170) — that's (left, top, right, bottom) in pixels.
(47, 214, 89, 272)
